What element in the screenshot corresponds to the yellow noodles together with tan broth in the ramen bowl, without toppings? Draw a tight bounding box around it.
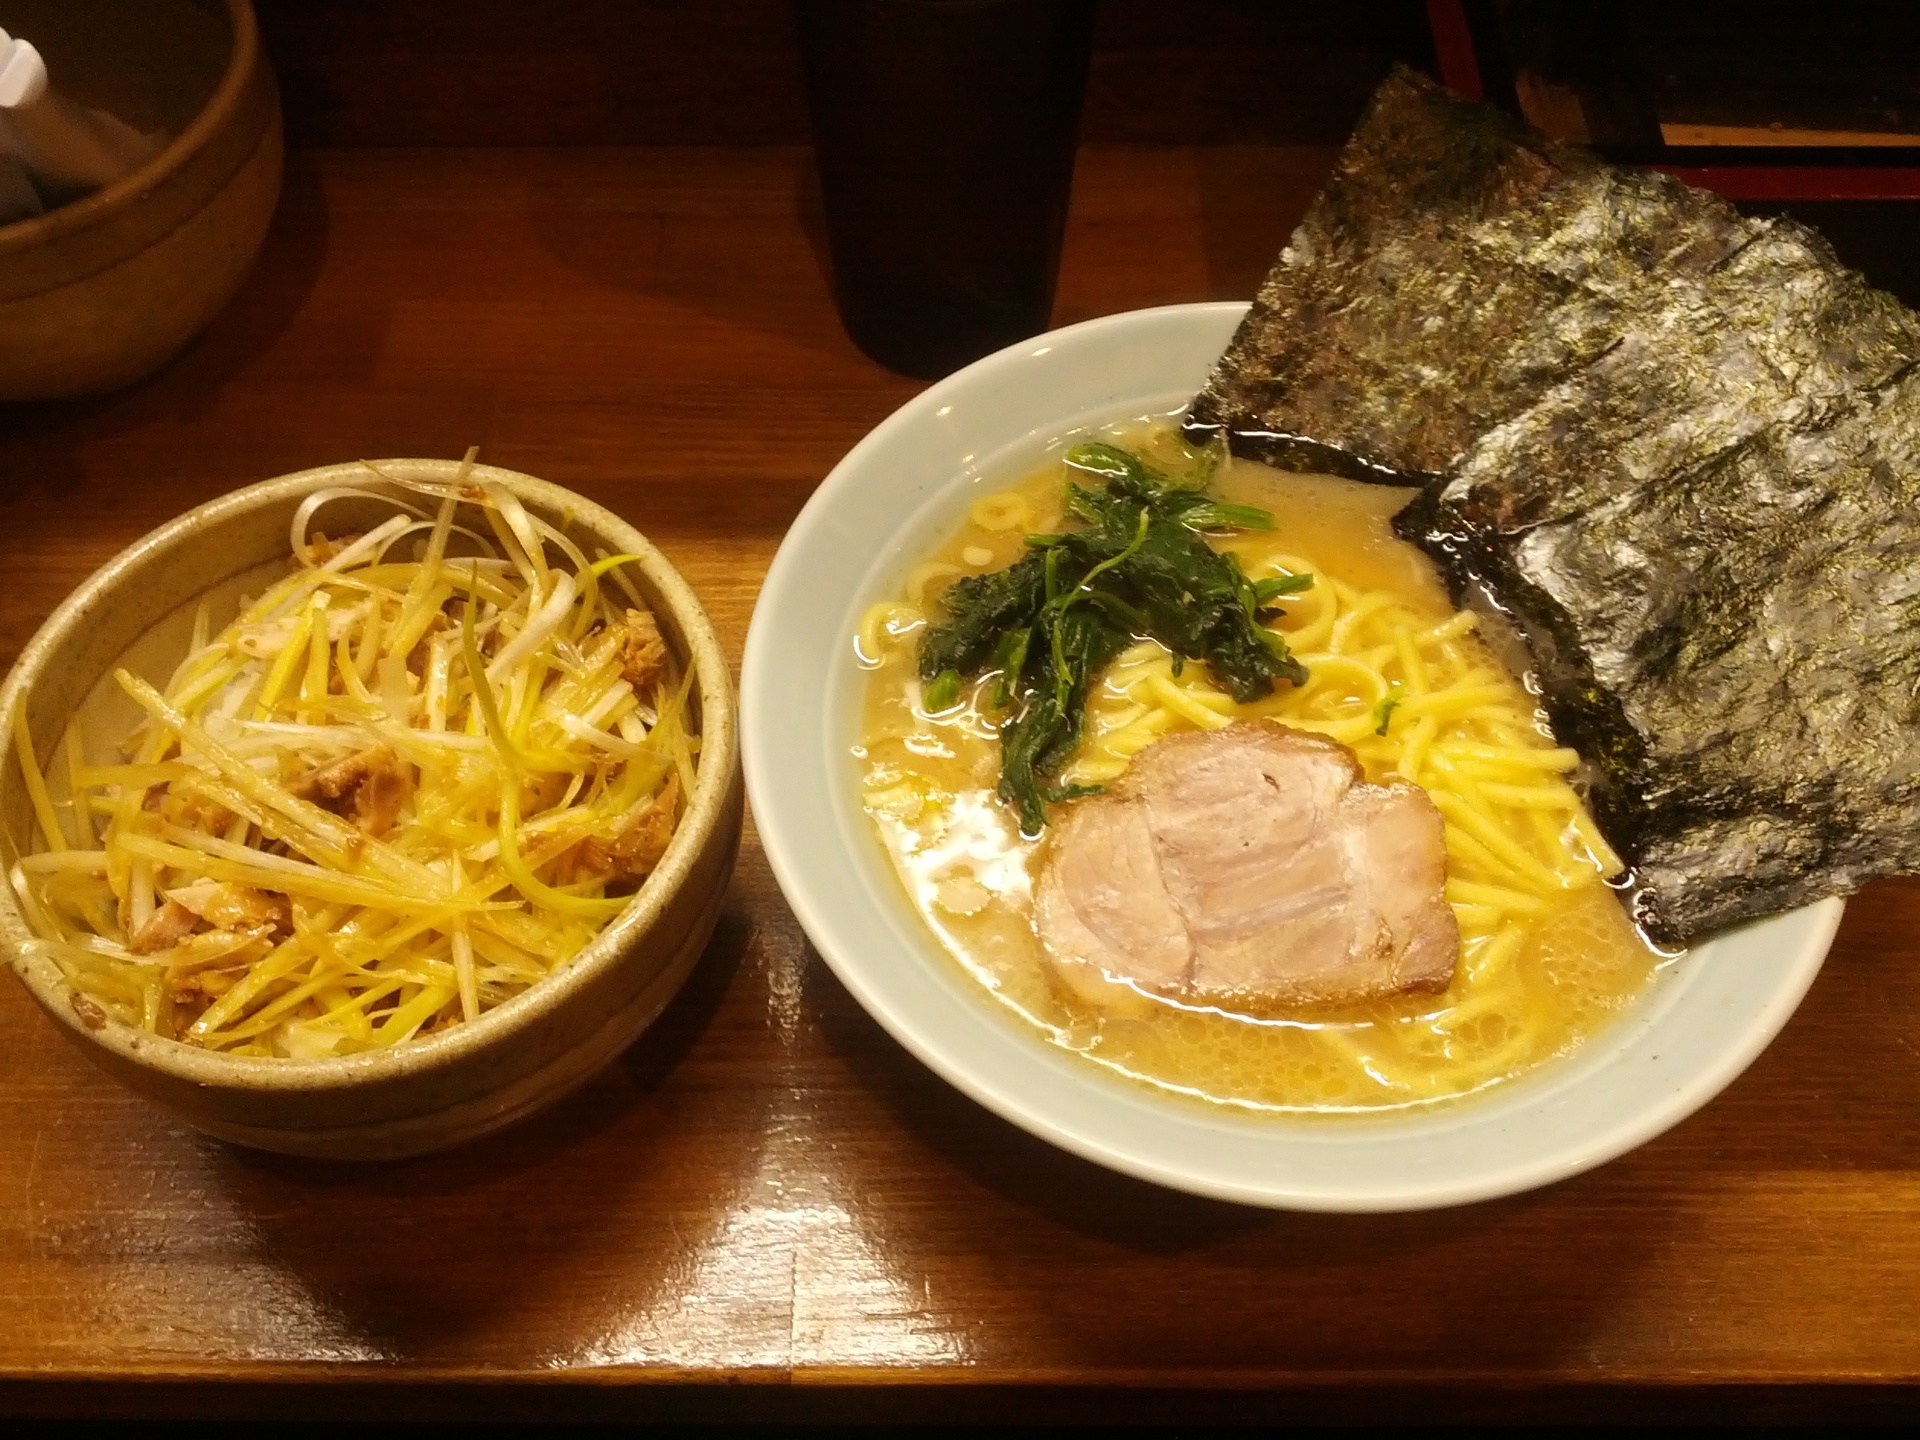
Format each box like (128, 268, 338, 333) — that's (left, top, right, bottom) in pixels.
(854, 422, 1661, 1112)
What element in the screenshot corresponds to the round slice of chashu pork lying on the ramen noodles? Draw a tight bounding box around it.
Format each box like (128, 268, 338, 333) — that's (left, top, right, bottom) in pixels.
(1035, 720, 1459, 1012)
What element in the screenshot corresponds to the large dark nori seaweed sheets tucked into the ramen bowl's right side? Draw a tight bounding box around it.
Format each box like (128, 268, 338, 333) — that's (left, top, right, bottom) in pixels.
(1190, 71, 1920, 943)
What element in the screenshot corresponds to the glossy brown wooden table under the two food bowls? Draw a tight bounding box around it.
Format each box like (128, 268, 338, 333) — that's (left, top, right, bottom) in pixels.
(0, 148, 1920, 1419)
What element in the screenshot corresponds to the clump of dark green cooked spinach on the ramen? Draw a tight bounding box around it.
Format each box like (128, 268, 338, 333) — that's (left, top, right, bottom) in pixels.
(920, 444, 1313, 835)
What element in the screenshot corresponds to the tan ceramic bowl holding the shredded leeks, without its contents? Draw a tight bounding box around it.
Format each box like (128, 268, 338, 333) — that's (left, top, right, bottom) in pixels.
(0, 461, 743, 1158)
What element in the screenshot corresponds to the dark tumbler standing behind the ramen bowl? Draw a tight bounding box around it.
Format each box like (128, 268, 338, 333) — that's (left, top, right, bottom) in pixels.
(793, 0, 1094, 380)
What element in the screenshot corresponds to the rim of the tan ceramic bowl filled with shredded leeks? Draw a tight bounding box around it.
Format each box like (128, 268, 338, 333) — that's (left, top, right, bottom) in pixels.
(0, 459, 739, 1091)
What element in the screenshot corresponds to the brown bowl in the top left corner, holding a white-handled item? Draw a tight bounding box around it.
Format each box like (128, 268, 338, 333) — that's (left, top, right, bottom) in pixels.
(0, 0, 284, 401)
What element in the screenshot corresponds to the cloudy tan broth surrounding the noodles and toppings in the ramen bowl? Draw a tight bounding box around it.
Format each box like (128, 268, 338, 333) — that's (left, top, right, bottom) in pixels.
(858, 416, 1657, 1114)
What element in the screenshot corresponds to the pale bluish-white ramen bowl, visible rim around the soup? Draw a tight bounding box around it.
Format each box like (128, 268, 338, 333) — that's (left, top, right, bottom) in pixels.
(741, 303, 1841, 1212)
